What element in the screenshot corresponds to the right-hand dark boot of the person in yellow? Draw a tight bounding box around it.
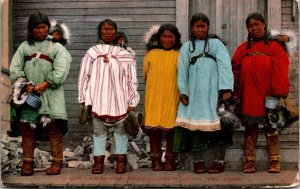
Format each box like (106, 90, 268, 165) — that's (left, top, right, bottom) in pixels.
(164, 129, 176, 171)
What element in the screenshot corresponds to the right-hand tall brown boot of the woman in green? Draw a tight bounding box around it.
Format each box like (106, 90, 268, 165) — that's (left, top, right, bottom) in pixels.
(46, 120, 63, 175)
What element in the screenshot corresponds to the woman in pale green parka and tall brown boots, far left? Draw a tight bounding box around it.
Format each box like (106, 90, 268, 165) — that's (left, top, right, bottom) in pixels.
(10, 13, 72, 176)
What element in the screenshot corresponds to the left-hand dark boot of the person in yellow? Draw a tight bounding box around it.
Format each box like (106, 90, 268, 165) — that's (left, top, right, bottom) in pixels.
(148, 129, 164, 171)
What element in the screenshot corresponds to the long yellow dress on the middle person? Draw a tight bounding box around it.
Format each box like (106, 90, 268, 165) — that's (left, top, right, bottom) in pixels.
(143, 49, 179, 129)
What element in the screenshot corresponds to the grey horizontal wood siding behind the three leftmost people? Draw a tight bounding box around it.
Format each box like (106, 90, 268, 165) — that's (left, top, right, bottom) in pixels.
(13, 0, 176, 144)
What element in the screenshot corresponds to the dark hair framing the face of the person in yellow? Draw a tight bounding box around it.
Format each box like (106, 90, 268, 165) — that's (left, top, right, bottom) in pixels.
(146, 24, 182, 51)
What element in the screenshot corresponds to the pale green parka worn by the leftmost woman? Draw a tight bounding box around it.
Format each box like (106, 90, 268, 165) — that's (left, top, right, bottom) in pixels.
(10, 40, 72, 122)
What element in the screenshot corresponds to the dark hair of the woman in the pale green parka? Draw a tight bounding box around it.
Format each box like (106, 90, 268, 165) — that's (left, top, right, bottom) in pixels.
(27, 12, 50, 45)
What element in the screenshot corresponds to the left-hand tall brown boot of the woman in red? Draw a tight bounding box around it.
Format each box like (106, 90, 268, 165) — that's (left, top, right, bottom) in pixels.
(243, 126, 259, 173)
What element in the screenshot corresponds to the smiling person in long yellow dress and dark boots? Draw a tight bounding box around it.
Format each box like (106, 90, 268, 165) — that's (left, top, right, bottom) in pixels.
(143, 24, 181, 171)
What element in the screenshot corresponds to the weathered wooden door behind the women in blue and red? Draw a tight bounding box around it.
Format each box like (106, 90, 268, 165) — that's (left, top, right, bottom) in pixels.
(189, 0, 266, 55)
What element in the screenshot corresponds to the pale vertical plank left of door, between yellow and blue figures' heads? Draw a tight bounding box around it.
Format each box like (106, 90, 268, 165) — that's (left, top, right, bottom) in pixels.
(176, 0, 189, 42)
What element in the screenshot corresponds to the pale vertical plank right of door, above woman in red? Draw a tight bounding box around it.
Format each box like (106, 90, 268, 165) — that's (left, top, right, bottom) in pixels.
(267, 0, 281, 30)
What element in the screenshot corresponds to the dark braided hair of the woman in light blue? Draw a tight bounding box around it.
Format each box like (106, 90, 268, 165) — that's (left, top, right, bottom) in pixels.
(189, 13, 209, 52)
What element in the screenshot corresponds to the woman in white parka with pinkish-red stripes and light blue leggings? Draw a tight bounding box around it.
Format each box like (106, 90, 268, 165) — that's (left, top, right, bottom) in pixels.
(78, 19, 140, 174)
